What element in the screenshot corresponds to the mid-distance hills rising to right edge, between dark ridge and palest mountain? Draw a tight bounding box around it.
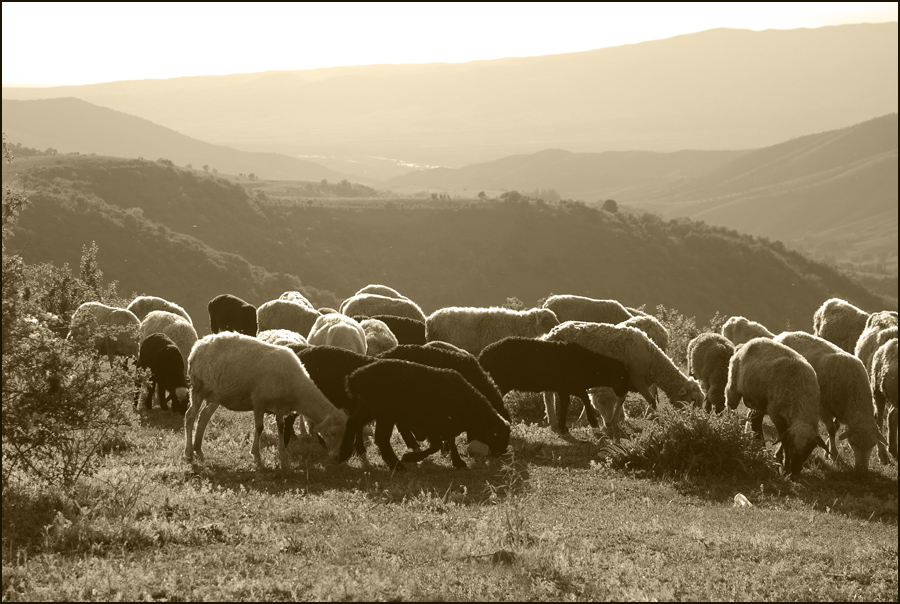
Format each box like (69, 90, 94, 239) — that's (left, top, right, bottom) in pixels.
(383, 113, 898, 267)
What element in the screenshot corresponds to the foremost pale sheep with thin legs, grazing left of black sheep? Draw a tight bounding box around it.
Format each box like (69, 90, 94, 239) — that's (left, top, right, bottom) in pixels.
(184, 332, 347, 470)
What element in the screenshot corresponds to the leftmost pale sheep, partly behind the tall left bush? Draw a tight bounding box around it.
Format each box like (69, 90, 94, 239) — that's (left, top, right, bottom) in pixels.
(66, 302, 141, 367)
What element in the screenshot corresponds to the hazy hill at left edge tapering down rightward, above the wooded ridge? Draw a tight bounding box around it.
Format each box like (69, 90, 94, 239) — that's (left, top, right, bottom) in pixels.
(3, 98, 358, 182)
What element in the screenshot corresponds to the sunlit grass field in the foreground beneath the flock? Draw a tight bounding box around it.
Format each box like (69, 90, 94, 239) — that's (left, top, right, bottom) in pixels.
(3, 394, 898, 601)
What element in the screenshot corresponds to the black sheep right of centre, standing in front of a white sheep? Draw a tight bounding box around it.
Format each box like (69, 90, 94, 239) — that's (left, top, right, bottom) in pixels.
(478, 337, 629, 433)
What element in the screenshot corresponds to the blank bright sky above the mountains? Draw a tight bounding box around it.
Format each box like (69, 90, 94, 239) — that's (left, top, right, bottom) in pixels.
(2, 2, 898, 86)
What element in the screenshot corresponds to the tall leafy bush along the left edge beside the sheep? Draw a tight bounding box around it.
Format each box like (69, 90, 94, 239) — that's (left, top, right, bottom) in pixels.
(2, 140, 137, 489)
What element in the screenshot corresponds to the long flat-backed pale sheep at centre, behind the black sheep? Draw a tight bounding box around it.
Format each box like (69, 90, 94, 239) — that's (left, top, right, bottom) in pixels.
(425, 306, 559, 355)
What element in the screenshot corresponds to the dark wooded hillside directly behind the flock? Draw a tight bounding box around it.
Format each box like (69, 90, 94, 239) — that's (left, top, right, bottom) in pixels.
(4, 150, 888, 331)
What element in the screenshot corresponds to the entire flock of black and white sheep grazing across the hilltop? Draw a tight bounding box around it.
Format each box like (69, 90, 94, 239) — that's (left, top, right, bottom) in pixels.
(69, 285, 897, 476)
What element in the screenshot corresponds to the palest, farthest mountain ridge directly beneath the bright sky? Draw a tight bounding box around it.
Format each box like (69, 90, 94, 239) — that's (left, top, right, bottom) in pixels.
(3, 22, 898, 178)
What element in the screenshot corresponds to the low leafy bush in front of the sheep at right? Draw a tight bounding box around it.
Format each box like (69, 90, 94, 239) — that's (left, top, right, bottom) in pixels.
(601, 405, 778, 480)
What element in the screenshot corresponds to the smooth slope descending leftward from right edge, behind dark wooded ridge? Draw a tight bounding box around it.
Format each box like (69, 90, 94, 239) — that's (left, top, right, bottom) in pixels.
(621, 113, 898, 271)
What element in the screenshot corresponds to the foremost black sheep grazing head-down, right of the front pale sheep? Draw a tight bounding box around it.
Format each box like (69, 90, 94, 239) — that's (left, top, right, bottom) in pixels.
(341, 359, 510, 470)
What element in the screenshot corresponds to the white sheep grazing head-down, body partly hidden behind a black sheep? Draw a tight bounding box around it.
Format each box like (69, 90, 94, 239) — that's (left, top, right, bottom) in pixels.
(543, 321, 703, 431)
